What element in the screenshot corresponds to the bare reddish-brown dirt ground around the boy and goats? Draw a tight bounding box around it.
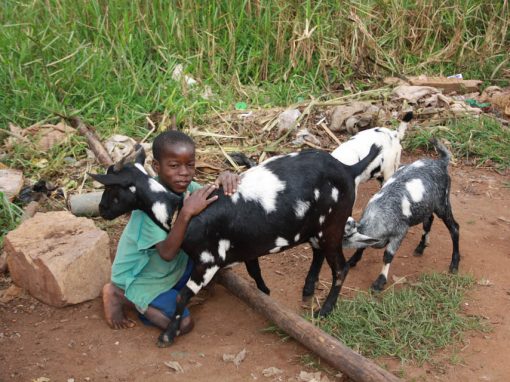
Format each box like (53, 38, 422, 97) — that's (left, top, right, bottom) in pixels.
(0, 153, 510, 381)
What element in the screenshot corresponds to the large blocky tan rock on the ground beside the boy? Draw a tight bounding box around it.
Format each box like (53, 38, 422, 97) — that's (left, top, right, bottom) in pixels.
(4, 211, 111, 307)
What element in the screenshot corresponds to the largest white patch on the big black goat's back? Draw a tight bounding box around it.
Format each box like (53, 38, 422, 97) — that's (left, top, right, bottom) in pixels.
(232, 166, 285, 213)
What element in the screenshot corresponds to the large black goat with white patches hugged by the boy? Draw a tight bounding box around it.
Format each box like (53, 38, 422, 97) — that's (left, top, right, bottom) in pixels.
(91, 146, 380, 346)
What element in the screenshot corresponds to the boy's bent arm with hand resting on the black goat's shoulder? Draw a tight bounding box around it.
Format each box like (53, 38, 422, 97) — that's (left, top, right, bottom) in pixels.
(156, 184, 218, 261)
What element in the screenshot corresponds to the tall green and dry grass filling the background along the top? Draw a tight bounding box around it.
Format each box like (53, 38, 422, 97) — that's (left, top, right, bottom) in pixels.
(0, 0, 510, 136)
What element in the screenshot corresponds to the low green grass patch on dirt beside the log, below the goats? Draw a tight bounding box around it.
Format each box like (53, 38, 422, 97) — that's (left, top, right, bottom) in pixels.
(317, 273, 489, 364)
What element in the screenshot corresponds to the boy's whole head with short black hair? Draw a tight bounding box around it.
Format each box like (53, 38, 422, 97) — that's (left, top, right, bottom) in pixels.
(152, 130, 195, 193)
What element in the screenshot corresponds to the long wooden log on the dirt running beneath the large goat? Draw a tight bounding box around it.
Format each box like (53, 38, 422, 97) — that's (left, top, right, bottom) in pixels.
(218, 269, 400, 382)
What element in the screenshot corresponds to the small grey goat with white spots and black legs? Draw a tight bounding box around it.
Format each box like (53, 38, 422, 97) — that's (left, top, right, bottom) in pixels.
(343, 140, 460, 290)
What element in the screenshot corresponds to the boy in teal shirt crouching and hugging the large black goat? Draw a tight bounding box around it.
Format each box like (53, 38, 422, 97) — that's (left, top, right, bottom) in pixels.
(103, 130, 239, 334)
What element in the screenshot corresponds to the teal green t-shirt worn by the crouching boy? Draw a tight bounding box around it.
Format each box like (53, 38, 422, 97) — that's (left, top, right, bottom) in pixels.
(112, 182, 201, 311)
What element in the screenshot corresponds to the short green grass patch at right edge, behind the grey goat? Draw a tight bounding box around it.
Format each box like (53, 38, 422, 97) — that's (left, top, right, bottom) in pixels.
(404, 117, 510, 169)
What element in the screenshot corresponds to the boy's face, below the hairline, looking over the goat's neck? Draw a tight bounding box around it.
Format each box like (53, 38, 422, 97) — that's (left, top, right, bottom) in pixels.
(153, 143, 195, 193)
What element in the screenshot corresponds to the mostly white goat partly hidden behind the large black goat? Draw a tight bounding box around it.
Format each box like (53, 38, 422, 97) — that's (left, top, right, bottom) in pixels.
(331, 112, 413, 189)
